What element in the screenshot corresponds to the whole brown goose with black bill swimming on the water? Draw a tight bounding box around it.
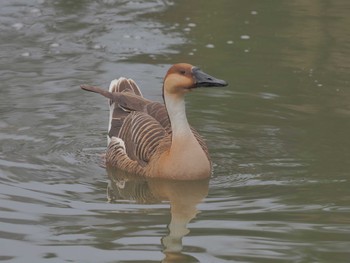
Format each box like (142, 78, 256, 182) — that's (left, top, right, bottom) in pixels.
(81, 63, 227, 180)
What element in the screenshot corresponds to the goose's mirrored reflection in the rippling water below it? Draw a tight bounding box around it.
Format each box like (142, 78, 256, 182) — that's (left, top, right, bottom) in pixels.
(107, 167, 209, 262)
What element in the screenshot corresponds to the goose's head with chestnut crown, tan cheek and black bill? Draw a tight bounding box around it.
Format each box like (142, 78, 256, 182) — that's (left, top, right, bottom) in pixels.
(163, 63, 227, 96)
